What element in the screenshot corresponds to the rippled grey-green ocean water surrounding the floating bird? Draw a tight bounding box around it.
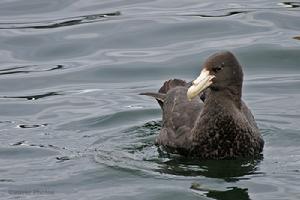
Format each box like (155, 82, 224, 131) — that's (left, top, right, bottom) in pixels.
(0, 0, 300, 200)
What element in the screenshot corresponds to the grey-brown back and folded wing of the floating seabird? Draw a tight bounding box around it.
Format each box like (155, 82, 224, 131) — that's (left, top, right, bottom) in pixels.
(152, 80, 203, 154)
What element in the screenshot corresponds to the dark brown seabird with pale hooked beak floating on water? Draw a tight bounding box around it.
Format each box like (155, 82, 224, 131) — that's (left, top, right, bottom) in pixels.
(142, 51, 264, 159)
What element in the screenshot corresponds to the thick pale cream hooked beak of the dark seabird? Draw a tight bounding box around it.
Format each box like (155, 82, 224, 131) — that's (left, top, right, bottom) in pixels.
(187, 68, 215, 101)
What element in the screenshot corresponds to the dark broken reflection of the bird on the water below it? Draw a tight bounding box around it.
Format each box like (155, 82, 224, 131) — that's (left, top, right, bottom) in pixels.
(157, 156, 263, 200)
